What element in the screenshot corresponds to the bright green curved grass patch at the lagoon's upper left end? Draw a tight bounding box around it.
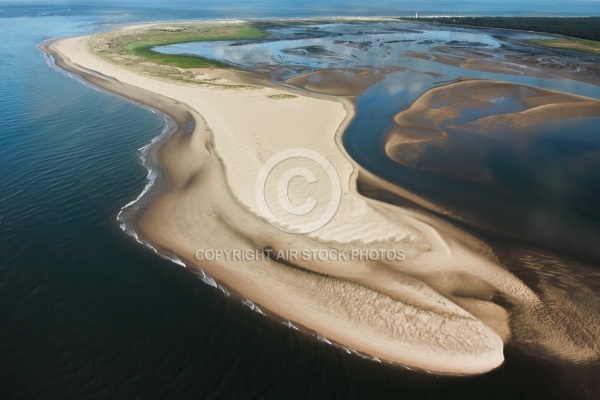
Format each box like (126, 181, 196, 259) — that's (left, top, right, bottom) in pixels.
(120, 25, 267, 68)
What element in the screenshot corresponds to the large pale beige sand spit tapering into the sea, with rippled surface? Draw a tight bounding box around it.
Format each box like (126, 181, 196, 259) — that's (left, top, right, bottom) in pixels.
(39, 24, 592, 374)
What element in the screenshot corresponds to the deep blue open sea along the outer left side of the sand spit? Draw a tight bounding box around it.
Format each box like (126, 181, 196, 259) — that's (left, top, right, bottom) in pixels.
(0, 2, 599, 399)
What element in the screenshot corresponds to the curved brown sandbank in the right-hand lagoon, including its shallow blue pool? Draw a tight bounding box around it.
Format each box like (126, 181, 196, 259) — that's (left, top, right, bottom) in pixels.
(385, 79, 600, 182)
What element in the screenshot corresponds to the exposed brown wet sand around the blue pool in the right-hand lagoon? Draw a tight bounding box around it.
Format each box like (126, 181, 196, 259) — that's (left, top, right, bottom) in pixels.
(385, 79, 600, 170)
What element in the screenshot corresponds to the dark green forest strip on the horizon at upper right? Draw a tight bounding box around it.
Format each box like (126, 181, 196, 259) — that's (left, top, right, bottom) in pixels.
(410, 17, 600, 41)
